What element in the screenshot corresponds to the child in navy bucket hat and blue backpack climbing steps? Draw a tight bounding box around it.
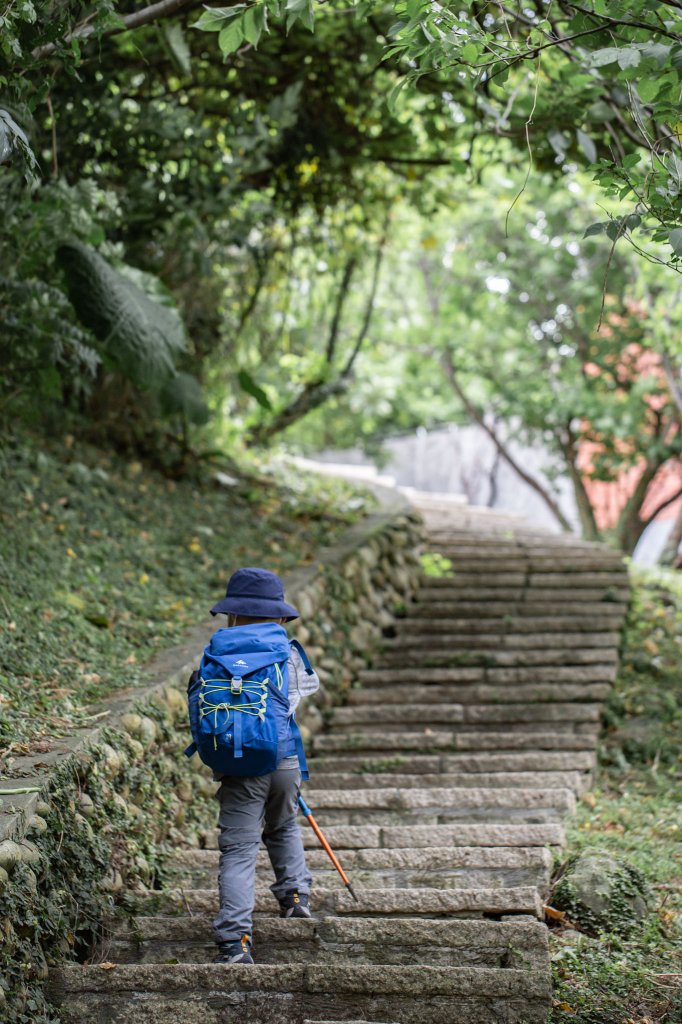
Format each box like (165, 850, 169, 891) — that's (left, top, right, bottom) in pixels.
(185, 568, 319, 964)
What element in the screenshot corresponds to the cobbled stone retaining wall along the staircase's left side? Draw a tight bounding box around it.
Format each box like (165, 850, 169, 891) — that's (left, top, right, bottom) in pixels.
(0, 488, 422, 1024)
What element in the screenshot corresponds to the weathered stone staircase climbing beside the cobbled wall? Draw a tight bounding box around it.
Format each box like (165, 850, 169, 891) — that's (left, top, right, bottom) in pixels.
(51, 499, 628, 1024)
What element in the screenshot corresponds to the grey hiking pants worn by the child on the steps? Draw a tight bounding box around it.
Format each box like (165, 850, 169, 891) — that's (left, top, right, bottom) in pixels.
(213, 768, 312, 942)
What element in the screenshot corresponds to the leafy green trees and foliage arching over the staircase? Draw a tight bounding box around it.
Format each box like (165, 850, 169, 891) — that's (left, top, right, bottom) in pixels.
(0, 0, 682, 551)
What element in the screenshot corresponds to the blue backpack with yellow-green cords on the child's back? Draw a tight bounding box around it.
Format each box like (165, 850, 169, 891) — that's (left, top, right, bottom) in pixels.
(184, 623, 312, 778)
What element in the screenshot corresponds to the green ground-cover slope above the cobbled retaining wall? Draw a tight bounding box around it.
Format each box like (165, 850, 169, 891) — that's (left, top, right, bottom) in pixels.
(0, 428, 361, 767)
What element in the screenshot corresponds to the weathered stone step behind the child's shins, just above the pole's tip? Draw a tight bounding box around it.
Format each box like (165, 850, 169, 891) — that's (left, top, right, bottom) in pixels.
(171, 847, 552, 892)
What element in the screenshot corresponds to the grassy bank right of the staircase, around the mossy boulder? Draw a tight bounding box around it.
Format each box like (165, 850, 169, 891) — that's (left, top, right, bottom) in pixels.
(552, 572, 682, 1024)
